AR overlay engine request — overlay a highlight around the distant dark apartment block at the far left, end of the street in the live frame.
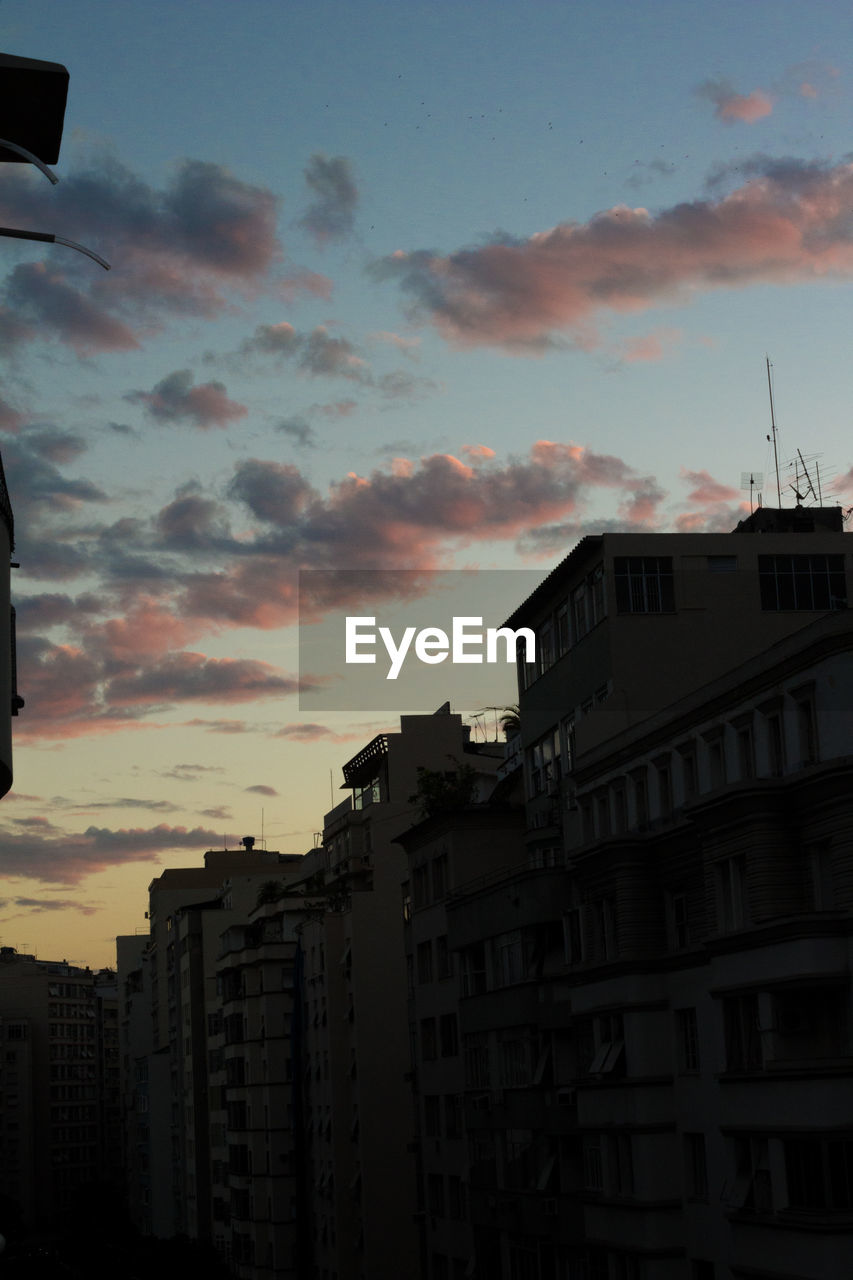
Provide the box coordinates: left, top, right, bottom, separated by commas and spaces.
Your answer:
0, 947, 117, 1229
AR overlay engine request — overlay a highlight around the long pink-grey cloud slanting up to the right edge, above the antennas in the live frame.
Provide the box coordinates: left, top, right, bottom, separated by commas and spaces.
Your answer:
374, 157, 853, 353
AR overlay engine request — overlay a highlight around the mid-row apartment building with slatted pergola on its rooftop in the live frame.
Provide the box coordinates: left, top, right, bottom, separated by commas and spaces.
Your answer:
301, 707, 500, 1280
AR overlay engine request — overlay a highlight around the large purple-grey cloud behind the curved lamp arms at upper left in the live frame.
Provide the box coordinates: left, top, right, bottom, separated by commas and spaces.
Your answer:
0, 156, 281, 356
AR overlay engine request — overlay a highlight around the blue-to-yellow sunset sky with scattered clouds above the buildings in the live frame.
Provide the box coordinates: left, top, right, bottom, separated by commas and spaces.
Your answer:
0, 0, 853, 966
